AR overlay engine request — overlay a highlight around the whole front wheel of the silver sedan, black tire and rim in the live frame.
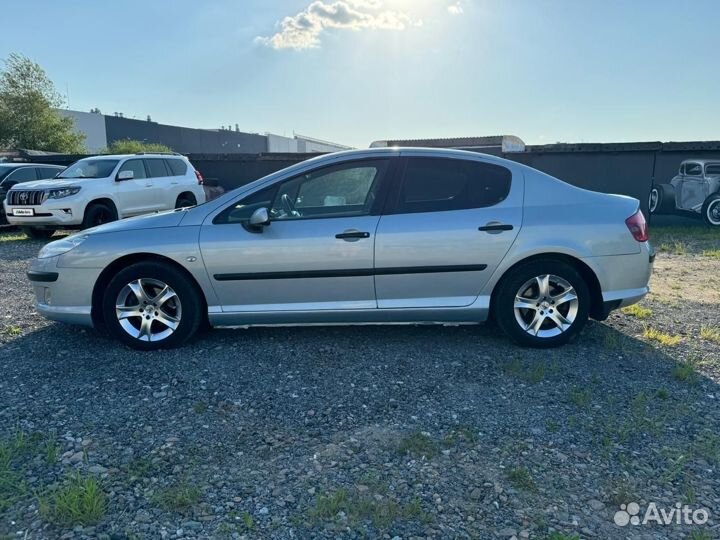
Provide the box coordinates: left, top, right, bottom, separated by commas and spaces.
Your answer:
102, 262, 204, 351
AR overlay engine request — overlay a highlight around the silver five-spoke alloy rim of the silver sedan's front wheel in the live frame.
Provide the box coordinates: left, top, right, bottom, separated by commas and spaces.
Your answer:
115, 278, 182, 342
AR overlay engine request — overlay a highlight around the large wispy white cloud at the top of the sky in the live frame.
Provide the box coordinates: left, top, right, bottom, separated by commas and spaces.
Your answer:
255, 0, 422, 49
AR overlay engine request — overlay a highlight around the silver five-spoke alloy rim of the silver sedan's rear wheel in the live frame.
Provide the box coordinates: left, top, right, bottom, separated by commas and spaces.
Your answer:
514, 274, 580, 338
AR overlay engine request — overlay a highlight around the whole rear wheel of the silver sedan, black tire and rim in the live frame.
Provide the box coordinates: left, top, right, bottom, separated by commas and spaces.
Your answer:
492, 259, 590, 348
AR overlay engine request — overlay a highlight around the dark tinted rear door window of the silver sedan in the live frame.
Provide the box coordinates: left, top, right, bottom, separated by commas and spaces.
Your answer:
396, 158, 512, 214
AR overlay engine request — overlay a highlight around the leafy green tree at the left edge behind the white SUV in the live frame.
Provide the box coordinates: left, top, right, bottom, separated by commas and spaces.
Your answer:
0, 53, 85, 154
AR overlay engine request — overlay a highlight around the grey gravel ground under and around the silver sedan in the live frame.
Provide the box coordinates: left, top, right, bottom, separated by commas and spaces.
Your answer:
0, 233, 720, 540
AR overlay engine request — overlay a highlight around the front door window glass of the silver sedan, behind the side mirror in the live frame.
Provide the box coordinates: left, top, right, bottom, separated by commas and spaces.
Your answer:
215, 160, 388, 223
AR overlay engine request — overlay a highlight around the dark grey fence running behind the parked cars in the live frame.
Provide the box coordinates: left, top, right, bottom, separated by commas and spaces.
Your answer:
23, 141, 720, 224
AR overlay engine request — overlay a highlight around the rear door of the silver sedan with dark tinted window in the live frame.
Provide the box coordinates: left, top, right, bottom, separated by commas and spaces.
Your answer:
375, 153, 524, 308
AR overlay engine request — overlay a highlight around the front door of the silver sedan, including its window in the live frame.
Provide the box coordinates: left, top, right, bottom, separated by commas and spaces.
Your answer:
200, 159, 390, 312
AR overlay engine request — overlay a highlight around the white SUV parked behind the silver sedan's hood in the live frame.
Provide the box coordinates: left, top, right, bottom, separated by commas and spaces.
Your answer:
5, 154, 205, 238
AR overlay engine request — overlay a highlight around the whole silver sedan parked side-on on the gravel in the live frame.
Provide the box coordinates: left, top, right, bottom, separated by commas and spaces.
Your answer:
28, 148, 653, 350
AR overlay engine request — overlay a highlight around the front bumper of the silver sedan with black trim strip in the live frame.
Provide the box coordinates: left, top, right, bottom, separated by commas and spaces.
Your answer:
27, 255, 101, 326
